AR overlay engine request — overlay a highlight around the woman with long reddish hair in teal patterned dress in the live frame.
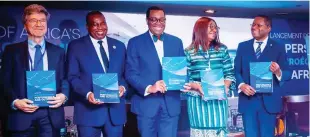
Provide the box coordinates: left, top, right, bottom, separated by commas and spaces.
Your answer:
184, 17, 235, 137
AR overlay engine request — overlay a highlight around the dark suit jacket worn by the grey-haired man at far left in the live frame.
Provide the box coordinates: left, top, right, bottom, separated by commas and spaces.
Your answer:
1, 41, 68, 131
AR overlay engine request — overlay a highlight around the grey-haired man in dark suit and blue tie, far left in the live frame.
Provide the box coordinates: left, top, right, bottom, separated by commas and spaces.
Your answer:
1, 4, 68, 137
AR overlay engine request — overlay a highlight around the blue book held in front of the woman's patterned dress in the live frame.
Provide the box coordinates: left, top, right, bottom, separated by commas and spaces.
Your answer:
200, 69, 227, 100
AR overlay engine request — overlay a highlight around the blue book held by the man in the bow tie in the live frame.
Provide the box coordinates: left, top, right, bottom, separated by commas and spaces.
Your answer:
162, 57, 188, 90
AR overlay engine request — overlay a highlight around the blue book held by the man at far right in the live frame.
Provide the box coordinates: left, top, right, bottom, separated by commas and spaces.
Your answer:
250, 62, 273, 93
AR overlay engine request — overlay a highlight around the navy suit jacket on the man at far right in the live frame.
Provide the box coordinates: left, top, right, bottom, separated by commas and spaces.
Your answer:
235, 38, 290, 113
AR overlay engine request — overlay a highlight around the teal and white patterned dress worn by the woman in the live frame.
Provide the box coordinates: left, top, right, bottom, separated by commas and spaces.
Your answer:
185, 45, 235, 137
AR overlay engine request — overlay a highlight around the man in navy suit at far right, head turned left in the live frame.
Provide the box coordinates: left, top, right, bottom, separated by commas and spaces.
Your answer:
235, 15, 290, 137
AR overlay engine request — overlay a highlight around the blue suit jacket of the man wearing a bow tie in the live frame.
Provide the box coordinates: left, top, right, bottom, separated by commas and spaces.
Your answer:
126, 31, 185, 117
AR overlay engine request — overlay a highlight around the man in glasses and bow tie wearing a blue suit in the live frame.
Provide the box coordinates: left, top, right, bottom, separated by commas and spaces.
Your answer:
126, 7, 184, 137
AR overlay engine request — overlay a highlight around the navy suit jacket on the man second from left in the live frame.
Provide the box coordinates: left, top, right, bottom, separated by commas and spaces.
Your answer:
67, 35, 128, 126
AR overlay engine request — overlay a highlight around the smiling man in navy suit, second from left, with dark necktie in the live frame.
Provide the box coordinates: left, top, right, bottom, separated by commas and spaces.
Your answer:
67, 11, 127, 137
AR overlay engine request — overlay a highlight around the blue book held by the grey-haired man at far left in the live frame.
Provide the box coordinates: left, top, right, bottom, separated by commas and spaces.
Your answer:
26, 71, 56, 107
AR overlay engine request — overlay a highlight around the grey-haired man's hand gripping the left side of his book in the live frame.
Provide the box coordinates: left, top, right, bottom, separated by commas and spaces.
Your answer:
14, 99, 39, 113
